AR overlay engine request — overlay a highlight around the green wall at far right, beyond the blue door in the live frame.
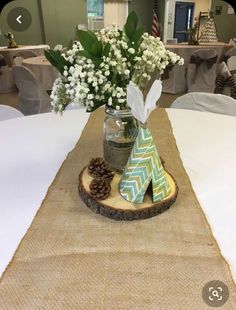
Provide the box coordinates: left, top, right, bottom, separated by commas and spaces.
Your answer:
211, 0, 236, 43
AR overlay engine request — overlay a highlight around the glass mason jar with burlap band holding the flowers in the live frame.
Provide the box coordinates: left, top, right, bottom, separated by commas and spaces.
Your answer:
103, 107, 138, 171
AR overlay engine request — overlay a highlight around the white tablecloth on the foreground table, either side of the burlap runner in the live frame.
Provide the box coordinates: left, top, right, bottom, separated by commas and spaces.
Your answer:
0, 109, 236, 280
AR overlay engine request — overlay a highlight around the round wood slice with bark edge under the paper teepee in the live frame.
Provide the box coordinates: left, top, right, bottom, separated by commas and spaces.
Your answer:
78, 167, 178, 221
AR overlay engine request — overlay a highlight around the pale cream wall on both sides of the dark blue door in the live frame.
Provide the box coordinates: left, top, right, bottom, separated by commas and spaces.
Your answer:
165, 0, 211, 39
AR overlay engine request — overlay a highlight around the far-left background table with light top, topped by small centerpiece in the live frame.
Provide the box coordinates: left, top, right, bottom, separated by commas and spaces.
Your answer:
0, 44, 49, 67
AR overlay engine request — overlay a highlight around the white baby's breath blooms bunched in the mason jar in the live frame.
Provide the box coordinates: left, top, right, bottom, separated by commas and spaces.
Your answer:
51, 26, 183, 112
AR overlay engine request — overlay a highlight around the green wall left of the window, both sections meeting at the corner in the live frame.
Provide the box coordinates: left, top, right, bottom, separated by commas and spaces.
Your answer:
0, 0, 87, 48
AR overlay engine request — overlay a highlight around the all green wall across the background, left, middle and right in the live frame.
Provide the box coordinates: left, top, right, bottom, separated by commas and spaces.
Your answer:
4, 0, 233, 47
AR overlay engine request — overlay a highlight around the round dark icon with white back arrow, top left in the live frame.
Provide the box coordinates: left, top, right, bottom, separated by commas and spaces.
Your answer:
7, 7, 32, 32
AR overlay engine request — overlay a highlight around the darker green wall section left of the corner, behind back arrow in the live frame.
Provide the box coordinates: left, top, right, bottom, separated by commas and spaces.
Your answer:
0, 0, 43, 46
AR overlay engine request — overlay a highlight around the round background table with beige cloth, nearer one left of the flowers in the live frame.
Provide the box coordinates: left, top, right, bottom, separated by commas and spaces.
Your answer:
22, 56, 58, 91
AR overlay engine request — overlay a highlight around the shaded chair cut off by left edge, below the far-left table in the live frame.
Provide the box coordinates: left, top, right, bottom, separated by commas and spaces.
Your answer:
0, 55, 15, 93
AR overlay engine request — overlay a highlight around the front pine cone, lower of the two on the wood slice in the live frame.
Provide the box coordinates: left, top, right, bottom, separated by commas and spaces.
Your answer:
89, 178, 111, 200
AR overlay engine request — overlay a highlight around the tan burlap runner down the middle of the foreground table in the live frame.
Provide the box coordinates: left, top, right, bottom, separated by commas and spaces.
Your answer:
0, 109, 236, 310
